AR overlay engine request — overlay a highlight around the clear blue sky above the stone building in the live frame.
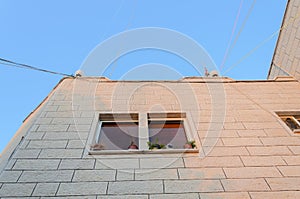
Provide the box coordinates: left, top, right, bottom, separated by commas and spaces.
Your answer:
0, 0, 286, 151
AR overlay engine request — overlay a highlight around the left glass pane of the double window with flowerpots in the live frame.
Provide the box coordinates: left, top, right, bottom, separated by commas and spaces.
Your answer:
99, 122, 139, 150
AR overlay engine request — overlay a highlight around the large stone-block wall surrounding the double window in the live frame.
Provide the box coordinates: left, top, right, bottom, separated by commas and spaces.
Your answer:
0, 78, 300, 199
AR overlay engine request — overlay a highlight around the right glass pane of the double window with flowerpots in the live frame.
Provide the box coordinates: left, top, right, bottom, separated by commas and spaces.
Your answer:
149, 121, 187, 149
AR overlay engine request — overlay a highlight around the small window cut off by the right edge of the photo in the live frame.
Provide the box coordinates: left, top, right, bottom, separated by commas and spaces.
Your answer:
277, 112, 300, 133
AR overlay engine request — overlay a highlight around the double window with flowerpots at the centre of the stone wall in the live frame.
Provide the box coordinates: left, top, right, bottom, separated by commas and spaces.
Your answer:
90, 113, 198, 153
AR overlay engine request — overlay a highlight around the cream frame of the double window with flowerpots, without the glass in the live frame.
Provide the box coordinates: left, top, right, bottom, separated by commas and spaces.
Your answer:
88, 112, 200, 155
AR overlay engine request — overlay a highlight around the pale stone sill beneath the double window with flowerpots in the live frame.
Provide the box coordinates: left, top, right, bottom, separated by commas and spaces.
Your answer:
89, 149, 199, 155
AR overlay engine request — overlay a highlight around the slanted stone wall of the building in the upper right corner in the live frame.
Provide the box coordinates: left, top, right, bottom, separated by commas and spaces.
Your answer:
268, 0, 300, 80
